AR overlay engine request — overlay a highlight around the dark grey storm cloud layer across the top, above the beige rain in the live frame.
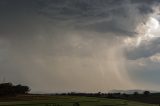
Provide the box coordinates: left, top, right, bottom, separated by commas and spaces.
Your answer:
0, 0, 156, 38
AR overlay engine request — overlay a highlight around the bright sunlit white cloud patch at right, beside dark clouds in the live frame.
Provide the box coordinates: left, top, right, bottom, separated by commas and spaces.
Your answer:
124, 17, 160, 47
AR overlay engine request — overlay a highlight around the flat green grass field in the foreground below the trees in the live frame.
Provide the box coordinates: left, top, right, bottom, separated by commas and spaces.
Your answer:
0, 96, 158, 106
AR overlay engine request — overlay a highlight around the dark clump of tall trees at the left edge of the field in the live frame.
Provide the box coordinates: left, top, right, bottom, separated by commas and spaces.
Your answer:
0, 83, 30, 96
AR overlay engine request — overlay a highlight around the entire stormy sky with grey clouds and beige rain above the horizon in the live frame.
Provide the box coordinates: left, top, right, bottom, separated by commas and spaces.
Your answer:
0, 0, 160, 93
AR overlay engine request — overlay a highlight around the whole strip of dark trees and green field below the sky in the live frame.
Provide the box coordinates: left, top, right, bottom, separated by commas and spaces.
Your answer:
0, 83, 160, 106
